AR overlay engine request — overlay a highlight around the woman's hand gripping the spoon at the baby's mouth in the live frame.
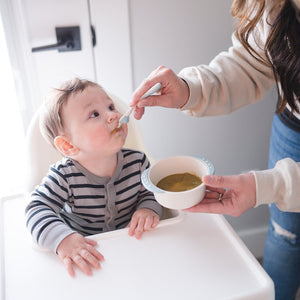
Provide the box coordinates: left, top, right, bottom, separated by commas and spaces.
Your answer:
130, 66, 190, 120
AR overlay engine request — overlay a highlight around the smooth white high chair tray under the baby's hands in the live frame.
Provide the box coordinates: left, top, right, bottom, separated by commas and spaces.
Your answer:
1, 199, 274, 300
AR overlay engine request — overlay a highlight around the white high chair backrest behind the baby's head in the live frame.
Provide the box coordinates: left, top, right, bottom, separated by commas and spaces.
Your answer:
26, 92, 152, 192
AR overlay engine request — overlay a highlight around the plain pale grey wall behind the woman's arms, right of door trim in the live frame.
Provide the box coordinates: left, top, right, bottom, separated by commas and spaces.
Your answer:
129, 0, 276, 256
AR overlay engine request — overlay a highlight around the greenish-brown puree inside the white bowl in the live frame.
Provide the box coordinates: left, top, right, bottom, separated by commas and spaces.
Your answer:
157, 173, 202, 192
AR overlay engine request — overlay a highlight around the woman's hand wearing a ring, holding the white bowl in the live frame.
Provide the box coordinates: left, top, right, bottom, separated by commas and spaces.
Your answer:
185, 173, 256, 217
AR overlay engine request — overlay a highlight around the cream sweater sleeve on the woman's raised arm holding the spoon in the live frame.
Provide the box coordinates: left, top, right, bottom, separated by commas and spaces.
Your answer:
179, 10, 275, 117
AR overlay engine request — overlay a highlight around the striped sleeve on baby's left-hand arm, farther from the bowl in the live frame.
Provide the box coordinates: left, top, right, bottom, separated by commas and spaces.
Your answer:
25, 166, 74, 253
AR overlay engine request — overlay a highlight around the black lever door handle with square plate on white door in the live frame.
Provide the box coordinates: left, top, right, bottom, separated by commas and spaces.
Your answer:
31, 26, 81, 52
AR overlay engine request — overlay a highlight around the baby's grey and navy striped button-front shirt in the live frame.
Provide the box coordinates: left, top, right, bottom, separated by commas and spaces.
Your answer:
26, 149, 162, 252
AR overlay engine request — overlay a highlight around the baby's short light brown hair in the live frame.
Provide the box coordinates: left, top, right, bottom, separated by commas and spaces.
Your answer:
39, 78, 100, 148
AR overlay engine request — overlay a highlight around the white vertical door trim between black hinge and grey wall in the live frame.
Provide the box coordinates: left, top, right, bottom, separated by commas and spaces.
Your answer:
89, 0, 132, 100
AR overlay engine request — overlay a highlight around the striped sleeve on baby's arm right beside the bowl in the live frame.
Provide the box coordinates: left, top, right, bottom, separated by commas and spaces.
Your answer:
136, 154, 163, 219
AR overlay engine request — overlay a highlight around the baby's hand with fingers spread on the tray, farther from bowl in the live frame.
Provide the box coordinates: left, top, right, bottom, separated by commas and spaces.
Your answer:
57, 233, 104, 277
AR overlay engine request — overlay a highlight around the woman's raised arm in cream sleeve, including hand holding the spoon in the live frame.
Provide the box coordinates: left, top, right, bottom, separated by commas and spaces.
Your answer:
131, 9, 275, 119
